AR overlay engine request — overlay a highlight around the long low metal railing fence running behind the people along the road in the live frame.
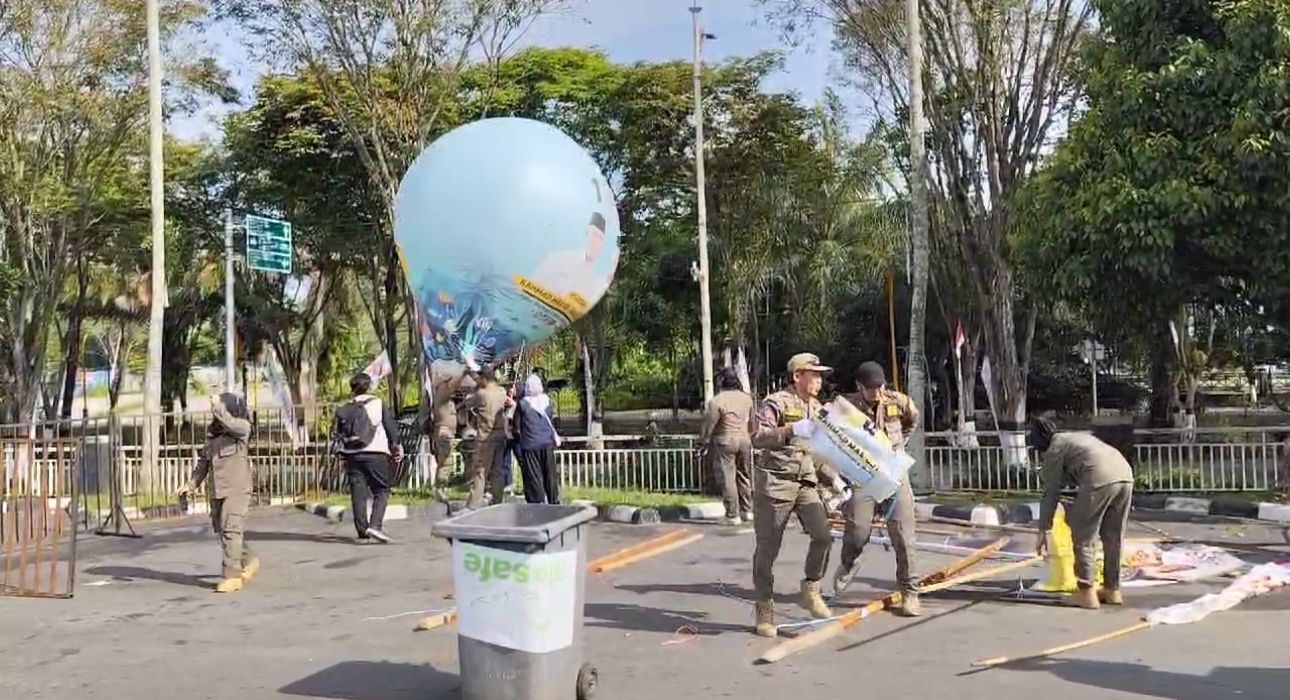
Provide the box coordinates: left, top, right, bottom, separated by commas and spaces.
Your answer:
0, 409, 1290, 513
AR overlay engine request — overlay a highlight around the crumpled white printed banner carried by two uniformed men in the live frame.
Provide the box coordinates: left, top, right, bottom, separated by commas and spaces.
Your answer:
808, 397, 913, 501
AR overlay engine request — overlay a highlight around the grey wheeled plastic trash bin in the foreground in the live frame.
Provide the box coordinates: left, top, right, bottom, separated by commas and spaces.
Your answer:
432, 503, 597, 700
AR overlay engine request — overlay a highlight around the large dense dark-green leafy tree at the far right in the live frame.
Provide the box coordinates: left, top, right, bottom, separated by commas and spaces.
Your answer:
1022, 0, 1290, 422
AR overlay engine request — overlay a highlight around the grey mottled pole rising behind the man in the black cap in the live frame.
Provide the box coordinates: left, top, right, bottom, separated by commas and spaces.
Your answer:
904, 0, 933, 490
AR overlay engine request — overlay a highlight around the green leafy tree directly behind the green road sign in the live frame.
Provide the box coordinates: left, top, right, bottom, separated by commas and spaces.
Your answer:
224, 76, 381, 403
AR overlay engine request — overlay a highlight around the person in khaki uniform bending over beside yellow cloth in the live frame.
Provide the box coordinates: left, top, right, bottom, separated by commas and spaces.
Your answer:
1029, 418, 1133, 610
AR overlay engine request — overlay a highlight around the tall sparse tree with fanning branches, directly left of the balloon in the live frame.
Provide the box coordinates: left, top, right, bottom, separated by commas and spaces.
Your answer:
219, 0, 562, 406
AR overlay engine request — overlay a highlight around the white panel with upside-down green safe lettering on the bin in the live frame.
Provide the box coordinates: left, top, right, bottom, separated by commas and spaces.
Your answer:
453, 540, 578, 654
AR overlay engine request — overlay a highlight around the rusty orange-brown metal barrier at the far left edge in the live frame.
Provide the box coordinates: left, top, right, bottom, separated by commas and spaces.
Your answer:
0, 440, 80, 598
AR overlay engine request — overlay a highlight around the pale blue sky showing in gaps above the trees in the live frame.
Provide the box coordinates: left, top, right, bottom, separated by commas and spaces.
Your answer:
170, 0, 832, 139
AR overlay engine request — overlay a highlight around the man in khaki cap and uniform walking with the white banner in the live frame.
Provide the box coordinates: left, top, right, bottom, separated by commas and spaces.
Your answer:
752, 353, 836, 637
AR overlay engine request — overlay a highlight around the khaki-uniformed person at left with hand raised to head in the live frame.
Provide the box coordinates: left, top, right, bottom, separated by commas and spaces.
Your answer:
179, 393, 259, 593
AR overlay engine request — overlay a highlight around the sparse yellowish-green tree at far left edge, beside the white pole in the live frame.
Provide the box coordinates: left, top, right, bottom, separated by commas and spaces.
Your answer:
0, 0, 230, 423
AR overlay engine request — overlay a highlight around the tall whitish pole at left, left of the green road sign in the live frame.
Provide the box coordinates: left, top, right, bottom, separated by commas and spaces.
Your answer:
141, 0, 168, 489
